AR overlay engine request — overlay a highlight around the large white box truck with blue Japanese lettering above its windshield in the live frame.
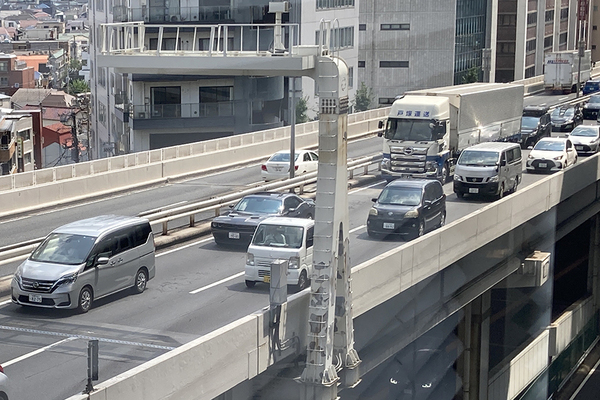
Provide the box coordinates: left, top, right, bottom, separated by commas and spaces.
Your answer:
379, 83, 524, 183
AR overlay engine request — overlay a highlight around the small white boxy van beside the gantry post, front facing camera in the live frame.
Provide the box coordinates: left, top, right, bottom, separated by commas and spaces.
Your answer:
245, 217, 315, 290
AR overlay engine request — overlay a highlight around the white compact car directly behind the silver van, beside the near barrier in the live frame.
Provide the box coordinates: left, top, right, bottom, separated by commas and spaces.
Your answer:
527, 138, 577, 172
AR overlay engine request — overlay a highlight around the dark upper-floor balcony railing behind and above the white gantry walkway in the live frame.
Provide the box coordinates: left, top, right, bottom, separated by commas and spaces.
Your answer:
113, 6, 232, 23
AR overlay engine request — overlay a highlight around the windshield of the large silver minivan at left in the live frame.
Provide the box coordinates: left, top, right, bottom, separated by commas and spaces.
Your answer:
29, 233, 96, 265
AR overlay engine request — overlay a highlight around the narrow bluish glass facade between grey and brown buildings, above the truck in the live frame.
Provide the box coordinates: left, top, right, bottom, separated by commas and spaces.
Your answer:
454, 0, 487, 85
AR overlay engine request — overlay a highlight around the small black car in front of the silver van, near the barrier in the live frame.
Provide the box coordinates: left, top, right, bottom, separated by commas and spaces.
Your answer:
367, 179, 446, 239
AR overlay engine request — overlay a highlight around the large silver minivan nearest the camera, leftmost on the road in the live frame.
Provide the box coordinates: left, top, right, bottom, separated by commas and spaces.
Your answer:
11, 215, 155, 312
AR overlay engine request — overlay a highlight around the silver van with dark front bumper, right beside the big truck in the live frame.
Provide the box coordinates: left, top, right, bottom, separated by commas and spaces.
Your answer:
454, 142, 523, 198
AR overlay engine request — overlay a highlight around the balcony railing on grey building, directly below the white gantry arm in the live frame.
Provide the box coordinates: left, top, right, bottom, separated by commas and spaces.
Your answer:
132, 101, 235, 119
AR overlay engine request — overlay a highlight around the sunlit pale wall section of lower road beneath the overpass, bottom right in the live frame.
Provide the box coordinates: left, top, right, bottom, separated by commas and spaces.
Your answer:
488, 330, 550, 400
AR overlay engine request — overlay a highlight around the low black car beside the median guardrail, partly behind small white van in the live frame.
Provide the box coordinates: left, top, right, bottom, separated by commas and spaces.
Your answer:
211, 192, 315, 246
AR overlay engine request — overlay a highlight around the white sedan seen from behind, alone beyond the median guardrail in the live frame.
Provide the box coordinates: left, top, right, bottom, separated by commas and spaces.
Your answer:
260, 150, 319, 181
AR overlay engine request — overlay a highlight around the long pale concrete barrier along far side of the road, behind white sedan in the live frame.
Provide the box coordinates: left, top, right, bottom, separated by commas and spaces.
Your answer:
0, 107, 389, 216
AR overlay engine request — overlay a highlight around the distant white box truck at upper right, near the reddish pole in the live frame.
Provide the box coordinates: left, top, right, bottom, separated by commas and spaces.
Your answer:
544, 50, 592, 93
